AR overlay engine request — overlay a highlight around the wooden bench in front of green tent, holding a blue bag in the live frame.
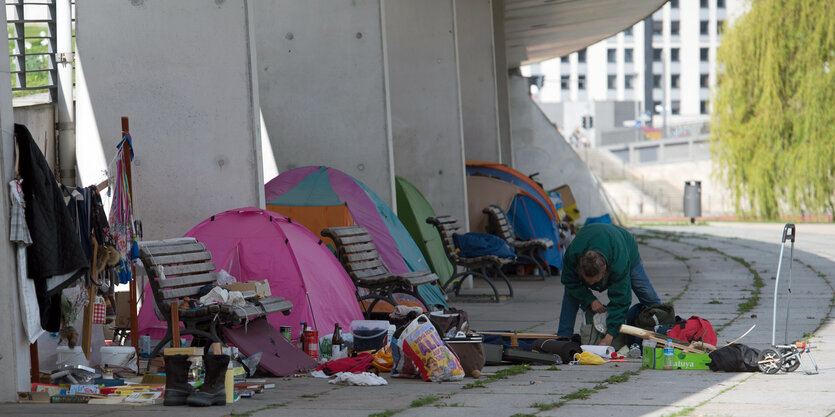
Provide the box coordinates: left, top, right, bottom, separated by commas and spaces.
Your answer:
426, 216, 514, 302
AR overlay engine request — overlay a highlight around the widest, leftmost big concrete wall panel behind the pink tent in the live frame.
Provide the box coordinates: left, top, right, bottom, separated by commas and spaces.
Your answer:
76, 0, 264, 239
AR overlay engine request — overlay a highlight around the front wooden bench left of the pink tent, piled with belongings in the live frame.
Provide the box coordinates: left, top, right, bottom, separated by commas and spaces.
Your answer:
139, 238, 293, 358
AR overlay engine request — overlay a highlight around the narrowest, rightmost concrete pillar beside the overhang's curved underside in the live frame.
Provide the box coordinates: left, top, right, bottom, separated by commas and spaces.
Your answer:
492, 0, 514, 166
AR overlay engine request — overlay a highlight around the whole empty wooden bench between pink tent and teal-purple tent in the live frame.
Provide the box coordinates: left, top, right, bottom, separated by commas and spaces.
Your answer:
322, 225, 438, 317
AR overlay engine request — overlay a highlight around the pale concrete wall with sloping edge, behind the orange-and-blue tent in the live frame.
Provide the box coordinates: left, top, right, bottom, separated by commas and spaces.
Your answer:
510, 77, 617, 223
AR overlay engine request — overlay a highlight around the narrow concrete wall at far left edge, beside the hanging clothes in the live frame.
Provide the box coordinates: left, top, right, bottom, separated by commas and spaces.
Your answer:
0, 1, 29, 396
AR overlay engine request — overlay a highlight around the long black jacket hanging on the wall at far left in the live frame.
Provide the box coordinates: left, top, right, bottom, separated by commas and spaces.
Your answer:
15, 124, 88, 332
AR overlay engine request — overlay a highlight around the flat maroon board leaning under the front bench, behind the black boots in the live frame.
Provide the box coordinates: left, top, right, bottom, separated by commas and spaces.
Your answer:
223, 318, 318, 376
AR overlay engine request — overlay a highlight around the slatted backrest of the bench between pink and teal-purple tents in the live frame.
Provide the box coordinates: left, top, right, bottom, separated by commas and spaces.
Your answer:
322, 225, 391, 284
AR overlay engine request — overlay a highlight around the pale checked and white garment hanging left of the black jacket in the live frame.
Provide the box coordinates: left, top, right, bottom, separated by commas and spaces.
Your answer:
9, 180, 44, 343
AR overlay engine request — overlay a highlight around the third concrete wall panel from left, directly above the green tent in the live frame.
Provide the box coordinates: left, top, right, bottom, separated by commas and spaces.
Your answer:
383, 0, 468, 225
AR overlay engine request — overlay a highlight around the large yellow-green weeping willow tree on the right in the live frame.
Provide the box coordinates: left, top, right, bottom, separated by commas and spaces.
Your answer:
711, 0, 835, 218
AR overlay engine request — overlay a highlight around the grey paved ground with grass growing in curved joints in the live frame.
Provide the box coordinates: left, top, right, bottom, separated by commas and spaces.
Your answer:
0, 222, 835, 417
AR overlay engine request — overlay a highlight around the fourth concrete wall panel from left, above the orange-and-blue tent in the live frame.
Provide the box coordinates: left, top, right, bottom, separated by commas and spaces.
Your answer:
455, 0, 506, 162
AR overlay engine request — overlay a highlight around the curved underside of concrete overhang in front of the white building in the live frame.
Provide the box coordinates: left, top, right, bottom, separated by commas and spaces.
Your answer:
504, 0, 667, 68
